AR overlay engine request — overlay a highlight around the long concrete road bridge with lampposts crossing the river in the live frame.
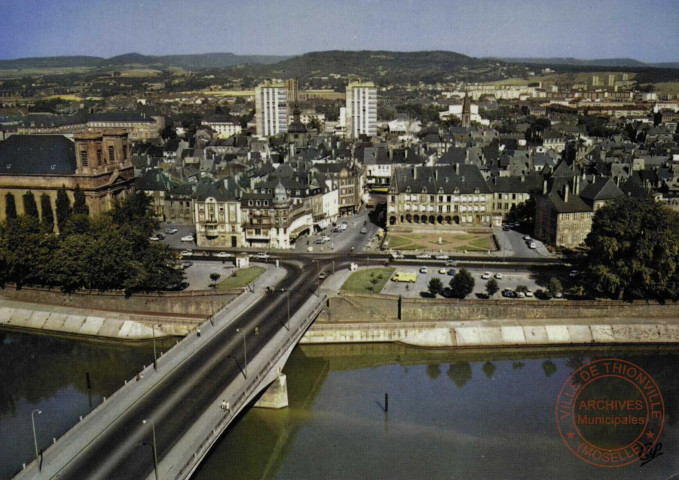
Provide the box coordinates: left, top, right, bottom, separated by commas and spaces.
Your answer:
15, 258, 336, 480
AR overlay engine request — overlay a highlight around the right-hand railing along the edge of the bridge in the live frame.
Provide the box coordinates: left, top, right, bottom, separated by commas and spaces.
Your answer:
175, 295, 328, 480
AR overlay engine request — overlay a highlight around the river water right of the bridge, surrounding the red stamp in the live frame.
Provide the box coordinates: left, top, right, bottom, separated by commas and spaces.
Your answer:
195, 344, 679, 480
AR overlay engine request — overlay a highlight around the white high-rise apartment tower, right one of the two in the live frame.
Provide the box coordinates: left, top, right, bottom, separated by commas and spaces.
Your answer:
346, 82, 377, 138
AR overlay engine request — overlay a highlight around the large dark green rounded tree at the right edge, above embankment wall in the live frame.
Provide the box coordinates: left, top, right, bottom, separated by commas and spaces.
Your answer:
584, 197, 679, 301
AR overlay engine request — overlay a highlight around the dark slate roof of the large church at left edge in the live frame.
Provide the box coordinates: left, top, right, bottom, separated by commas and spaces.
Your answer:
0, 135, 77, 175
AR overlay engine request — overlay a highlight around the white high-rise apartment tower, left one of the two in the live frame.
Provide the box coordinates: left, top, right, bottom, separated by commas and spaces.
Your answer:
255, 82, 288, 137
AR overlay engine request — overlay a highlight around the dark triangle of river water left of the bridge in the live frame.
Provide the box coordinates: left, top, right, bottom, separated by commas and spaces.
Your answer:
0, 330, 175, 479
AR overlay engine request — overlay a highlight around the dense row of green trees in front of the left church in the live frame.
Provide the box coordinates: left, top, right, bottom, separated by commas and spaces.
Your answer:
0, 192, 183, 293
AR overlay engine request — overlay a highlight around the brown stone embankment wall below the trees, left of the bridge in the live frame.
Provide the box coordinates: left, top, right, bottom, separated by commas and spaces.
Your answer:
0, 286, 242, 318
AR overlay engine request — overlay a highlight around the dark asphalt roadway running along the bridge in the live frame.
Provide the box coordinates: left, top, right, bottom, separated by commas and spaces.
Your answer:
51, 261, 327, 480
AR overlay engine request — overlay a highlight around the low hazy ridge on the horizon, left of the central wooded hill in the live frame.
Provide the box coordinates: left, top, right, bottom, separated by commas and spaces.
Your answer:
0, 53, 290, 70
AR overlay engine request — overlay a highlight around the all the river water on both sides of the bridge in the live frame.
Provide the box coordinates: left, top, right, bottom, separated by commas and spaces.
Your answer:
0, 332, 679, 480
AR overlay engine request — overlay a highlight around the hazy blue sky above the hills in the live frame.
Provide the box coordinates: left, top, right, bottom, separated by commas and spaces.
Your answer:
0, 0, 679, 62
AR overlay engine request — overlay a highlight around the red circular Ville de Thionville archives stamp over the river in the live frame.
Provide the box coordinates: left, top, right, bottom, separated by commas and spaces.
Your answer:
556, 358, 665, 467
